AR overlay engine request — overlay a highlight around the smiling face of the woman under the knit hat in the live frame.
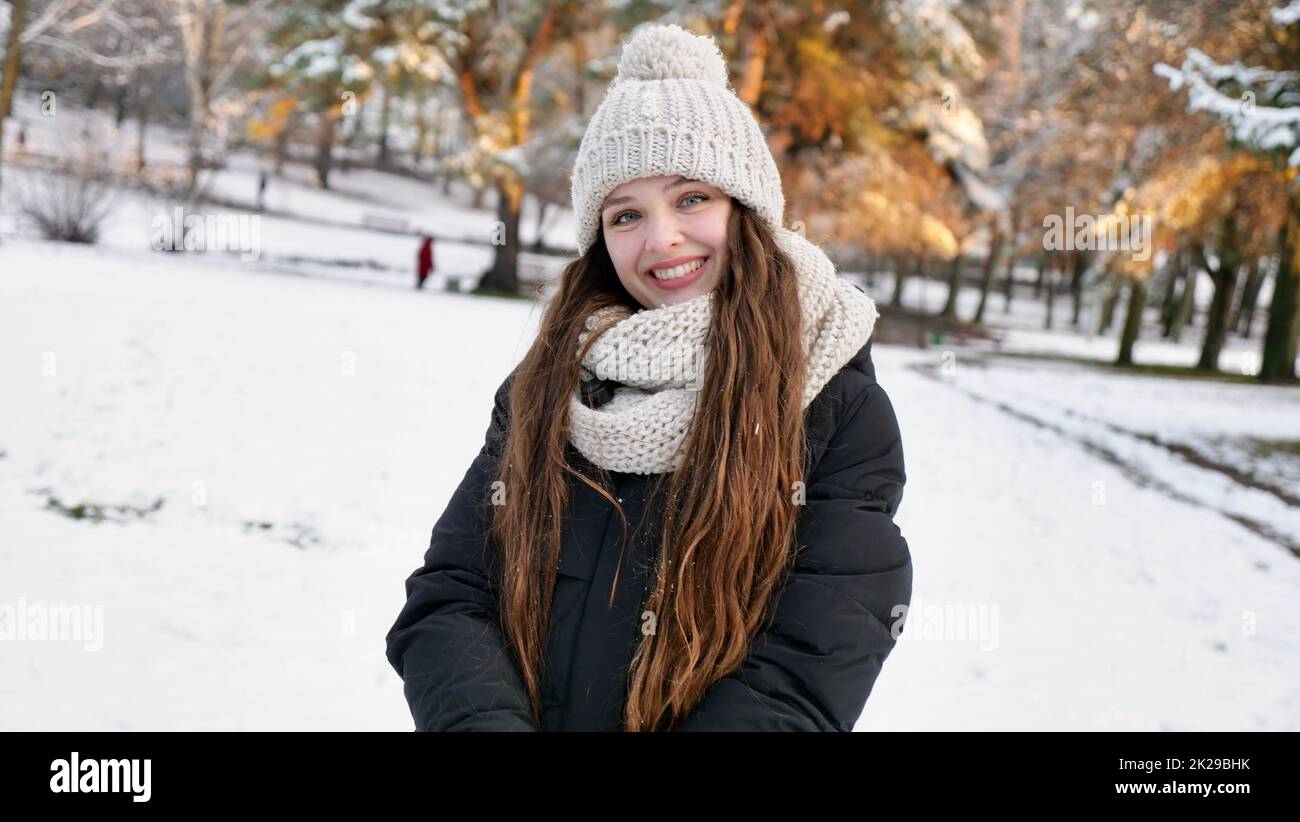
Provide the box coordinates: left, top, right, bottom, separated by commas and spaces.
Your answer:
601, 176, 733, 308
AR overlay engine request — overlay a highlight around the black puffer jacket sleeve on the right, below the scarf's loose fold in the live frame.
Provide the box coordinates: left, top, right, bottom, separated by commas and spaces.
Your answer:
677, 380, 911, 731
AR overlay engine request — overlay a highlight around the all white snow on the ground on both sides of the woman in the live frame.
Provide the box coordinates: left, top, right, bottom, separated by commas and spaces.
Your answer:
0, 237, 1300, 730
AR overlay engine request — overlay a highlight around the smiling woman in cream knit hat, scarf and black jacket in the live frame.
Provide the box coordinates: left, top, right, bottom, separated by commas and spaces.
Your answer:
387, 26, 911, 731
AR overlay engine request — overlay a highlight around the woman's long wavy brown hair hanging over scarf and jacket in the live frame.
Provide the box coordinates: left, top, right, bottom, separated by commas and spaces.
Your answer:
491, 200, 807, 731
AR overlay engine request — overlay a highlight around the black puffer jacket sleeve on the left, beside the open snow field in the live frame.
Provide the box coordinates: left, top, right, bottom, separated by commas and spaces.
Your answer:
386, 375, 537, 731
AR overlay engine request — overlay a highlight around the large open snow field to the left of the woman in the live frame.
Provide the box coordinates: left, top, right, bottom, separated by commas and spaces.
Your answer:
0, 242, 536, 730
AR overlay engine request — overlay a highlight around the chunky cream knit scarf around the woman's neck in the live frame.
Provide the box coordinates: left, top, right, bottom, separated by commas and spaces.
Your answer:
569, 228, 879, 473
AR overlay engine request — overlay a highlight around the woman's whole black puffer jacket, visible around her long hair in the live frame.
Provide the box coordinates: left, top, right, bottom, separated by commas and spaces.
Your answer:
387, 342, 911, 731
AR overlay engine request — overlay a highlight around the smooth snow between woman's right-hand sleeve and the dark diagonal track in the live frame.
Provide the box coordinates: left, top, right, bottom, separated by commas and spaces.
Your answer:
859, 346, 1300, 730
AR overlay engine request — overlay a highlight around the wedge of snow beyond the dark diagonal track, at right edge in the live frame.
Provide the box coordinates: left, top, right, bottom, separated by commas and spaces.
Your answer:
915, 351, 1300, 558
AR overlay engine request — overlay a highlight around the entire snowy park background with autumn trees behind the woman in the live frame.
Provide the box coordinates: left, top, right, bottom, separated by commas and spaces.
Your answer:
0, 0, 1300, 730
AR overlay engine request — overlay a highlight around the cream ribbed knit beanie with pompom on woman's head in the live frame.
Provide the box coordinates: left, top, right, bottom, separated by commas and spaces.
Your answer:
569, 23, 785, 255
